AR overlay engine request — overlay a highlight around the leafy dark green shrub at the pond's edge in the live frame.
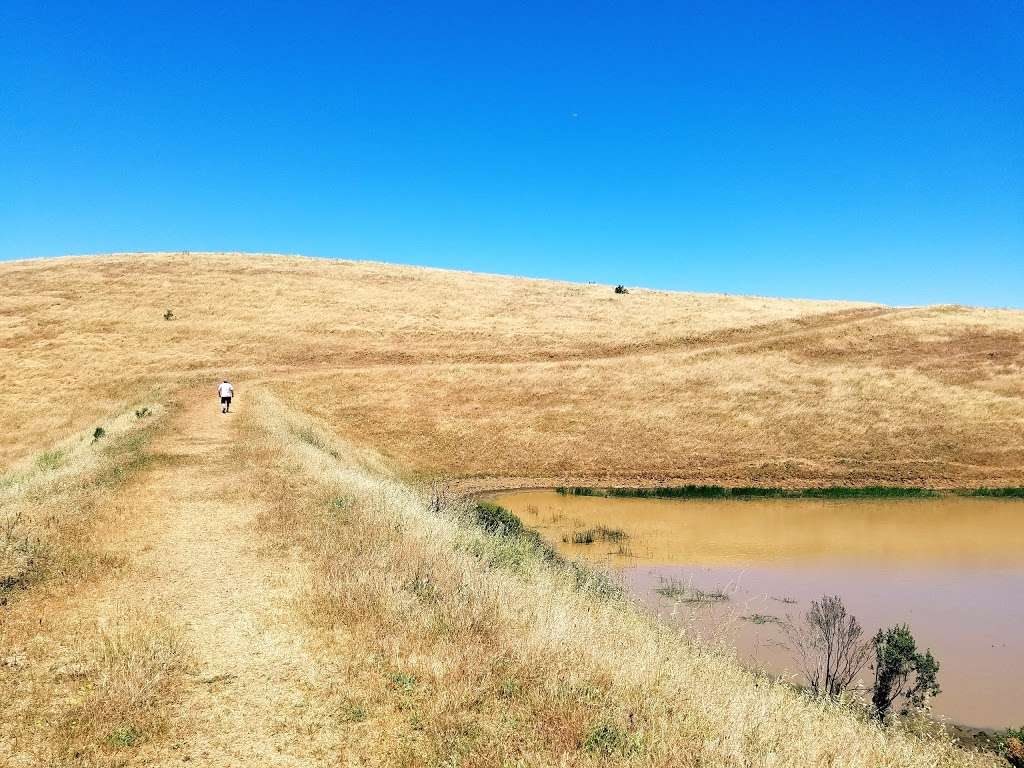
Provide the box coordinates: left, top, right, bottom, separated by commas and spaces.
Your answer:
871, 624, 941, 720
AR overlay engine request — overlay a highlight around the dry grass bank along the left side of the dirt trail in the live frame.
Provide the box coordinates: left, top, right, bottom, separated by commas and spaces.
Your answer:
0, 401, 187, 767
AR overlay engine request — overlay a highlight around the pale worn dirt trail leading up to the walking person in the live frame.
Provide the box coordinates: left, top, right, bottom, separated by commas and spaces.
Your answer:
112, 393, 338, 766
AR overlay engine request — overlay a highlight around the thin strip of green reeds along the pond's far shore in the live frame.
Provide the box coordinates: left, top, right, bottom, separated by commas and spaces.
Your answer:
555, 485, 1024, 499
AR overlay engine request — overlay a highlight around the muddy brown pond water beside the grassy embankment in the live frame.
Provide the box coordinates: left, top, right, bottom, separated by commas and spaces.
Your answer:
495, 490, 1024, 727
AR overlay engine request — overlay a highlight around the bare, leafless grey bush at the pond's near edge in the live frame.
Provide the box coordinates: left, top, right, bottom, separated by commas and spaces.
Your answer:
783, 595, 871, 696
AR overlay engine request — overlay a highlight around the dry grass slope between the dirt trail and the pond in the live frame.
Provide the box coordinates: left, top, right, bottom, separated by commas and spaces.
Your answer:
241, 393, 989, 768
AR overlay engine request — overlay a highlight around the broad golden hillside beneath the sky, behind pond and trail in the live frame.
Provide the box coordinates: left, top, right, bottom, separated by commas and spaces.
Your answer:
0, 254, 1024, 486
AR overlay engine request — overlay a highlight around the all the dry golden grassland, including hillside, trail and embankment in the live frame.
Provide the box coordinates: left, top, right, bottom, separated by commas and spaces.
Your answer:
0, 254, 1024, 768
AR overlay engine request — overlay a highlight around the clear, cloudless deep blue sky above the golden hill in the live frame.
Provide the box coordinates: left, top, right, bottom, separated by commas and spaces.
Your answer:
0, 0, 1024, 306
